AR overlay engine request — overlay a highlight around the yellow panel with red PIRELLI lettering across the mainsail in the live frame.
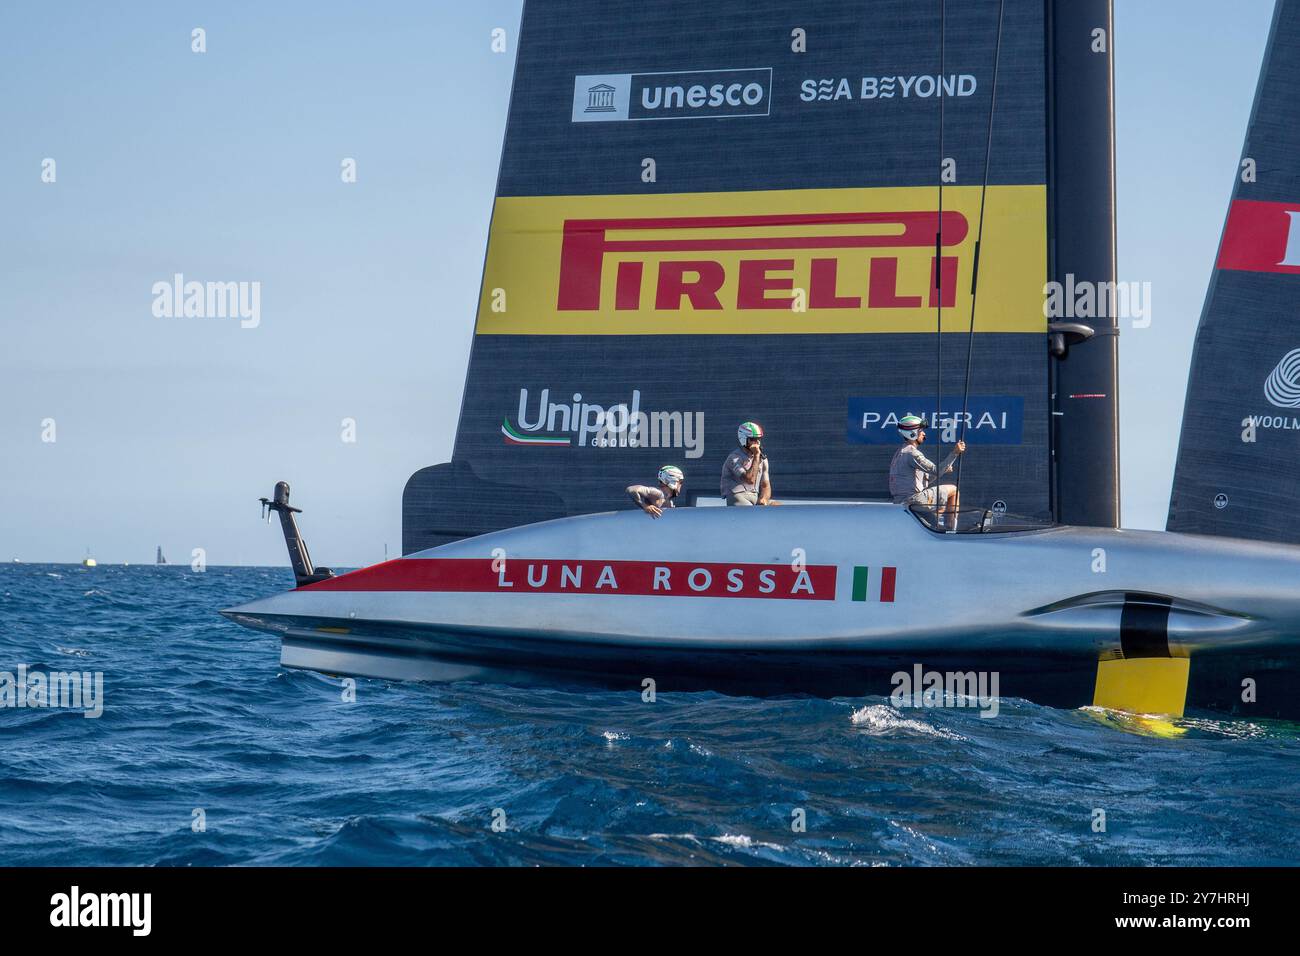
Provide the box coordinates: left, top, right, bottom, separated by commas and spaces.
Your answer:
476, 186, 1047, 336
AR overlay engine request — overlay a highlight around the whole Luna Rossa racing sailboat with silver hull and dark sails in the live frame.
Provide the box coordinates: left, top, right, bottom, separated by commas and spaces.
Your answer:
222, 0, 1300, 717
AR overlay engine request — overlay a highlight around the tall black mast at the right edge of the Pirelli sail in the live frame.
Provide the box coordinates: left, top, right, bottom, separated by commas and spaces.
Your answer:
1047, 0, 1119, 528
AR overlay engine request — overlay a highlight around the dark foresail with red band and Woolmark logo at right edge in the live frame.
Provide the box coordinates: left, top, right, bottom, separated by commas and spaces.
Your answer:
1167, 0, 1300, 544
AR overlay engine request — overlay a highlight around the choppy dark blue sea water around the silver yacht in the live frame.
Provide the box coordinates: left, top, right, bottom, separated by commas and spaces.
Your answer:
0, 564, 1300, 866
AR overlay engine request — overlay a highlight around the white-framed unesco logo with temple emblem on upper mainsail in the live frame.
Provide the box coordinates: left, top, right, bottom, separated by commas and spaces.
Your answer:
572, 66, 772, 122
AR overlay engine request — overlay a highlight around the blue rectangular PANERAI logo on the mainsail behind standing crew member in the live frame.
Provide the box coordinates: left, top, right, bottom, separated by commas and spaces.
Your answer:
846, 395, 1024, 445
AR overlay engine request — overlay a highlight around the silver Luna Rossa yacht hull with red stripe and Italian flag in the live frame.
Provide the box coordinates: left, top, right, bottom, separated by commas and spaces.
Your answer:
222, 503, 1300, 717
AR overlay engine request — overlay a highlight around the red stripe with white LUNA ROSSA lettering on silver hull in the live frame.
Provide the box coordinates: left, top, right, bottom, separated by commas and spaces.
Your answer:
304, 557, 837, 601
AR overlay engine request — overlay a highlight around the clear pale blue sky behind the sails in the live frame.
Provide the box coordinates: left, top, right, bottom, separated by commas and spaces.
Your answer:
0, 0, 1273, 566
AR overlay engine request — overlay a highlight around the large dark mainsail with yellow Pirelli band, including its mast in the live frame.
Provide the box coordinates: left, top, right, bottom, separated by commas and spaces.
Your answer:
403, 0, 1118, 553
